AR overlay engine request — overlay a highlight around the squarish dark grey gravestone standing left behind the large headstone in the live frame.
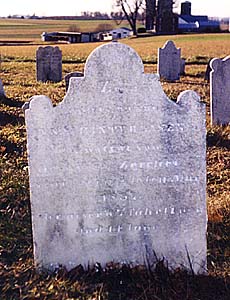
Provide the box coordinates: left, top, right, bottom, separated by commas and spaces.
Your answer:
36, 46, 62, 82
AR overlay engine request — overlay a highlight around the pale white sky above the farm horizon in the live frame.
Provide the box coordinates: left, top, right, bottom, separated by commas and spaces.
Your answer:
0, 0, 230, 17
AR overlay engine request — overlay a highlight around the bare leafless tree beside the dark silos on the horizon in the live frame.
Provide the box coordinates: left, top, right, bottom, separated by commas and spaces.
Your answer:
115, 0, 145, 35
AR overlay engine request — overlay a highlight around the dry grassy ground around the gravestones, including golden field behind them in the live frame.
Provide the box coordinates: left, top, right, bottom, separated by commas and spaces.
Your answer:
0, 34, 230, 300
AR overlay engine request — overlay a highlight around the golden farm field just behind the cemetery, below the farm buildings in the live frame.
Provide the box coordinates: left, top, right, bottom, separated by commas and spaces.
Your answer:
0, 34, 230, 64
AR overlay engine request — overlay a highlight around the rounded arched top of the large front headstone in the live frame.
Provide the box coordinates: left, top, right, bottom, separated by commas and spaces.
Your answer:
84, 42, 144, 82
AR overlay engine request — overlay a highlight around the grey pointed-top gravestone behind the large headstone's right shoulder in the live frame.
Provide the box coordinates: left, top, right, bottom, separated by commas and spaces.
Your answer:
157, 41, 182, 81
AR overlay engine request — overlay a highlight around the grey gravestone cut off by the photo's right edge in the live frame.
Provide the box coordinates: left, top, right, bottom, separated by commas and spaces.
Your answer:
210, 56, 230, 125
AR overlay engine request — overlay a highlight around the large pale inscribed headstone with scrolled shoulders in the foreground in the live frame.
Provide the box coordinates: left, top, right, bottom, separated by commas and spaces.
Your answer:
25, 43, 207, 272
